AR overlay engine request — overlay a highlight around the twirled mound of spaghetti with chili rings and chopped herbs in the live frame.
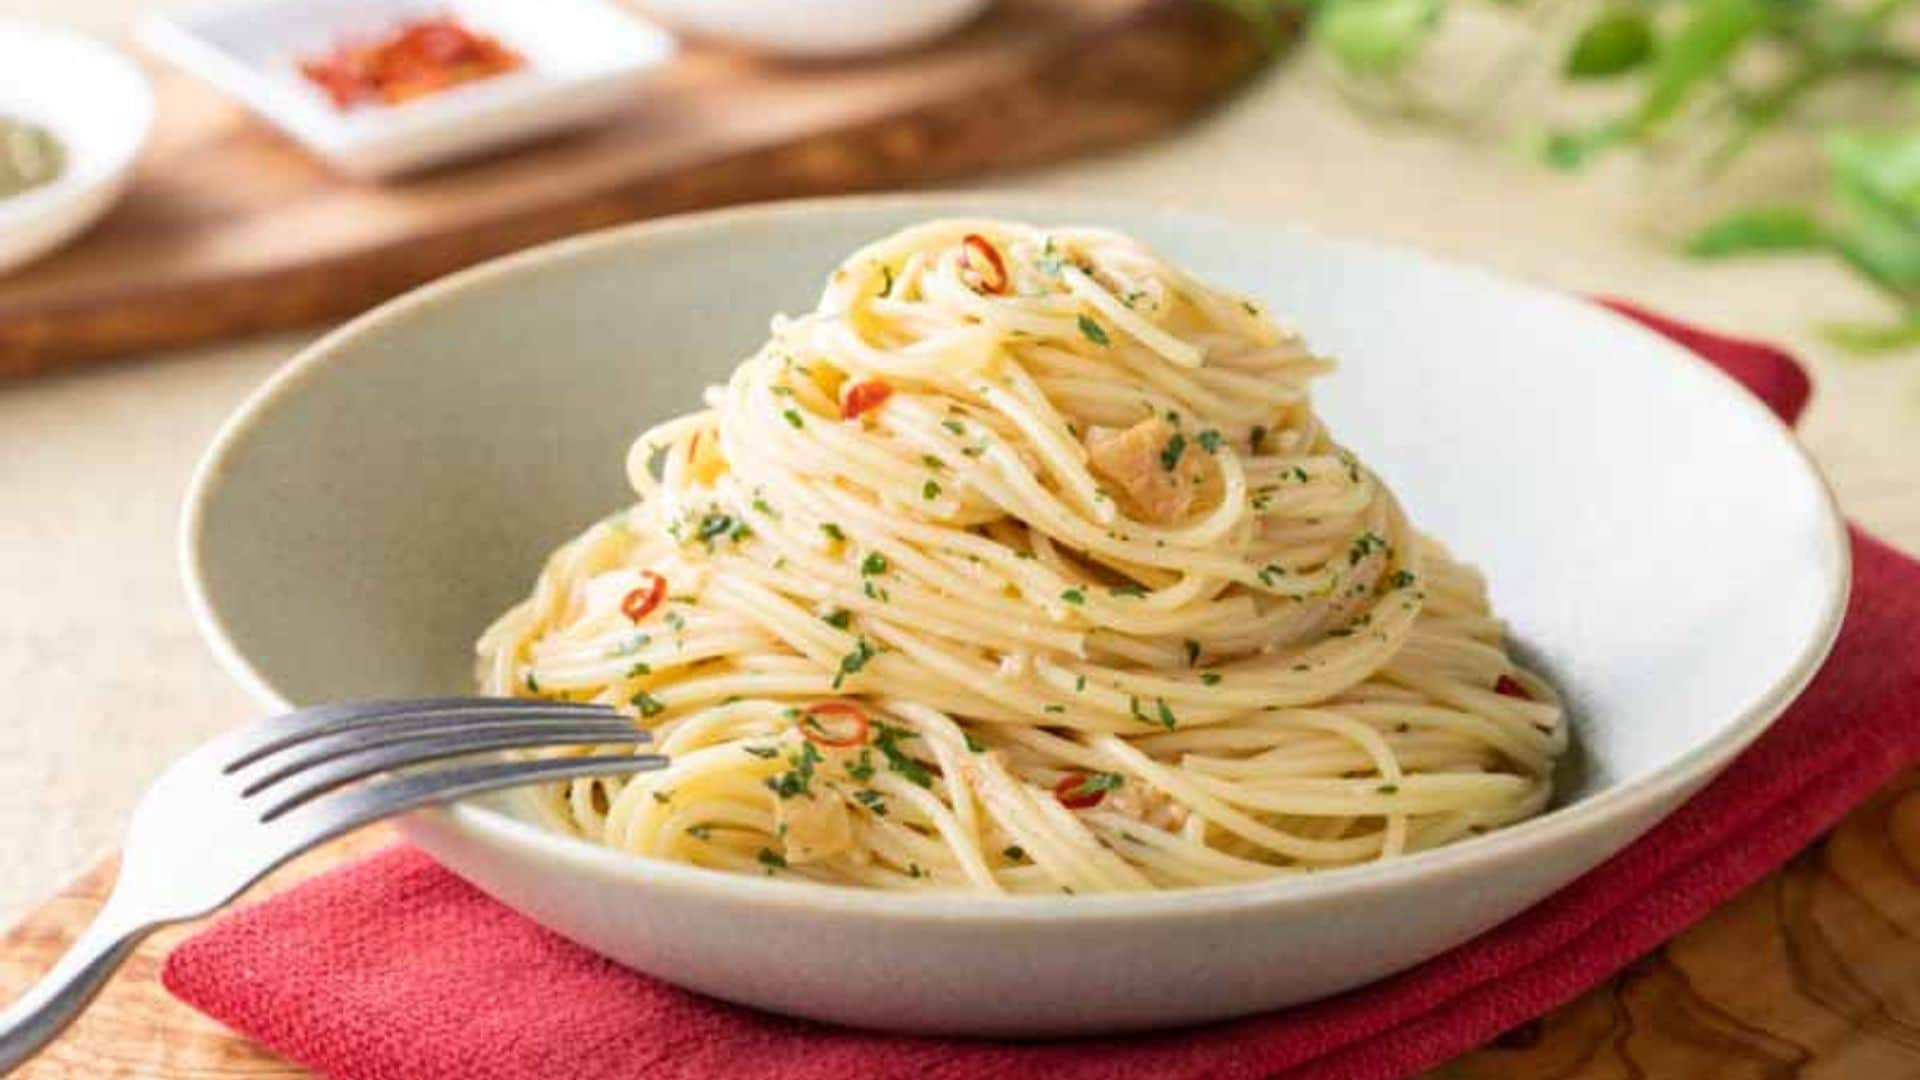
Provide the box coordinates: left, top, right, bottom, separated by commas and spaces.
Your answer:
478, 221, 1567, 894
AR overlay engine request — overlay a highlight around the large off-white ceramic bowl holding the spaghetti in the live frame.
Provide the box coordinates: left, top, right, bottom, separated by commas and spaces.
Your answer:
184, 196, 1849, 1036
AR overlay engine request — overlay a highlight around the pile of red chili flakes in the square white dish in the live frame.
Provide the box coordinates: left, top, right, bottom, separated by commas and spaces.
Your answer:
300, 15, 526, 110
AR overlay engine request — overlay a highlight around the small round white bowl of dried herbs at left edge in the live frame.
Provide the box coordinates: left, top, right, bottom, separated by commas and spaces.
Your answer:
0, 17, 154, 273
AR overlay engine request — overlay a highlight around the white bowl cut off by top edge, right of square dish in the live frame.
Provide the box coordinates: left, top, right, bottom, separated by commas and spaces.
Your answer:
632, 0, 993, 60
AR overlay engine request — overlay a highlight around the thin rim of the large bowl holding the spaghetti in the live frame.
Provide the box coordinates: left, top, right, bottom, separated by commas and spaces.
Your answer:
179, 190, 1853, 922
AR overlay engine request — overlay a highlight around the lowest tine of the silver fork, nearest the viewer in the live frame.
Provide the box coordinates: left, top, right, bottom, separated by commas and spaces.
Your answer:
266, 753, 668, 847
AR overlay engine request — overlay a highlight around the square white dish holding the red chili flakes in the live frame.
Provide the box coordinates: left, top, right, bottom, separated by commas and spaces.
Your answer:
138, 0, 674, 177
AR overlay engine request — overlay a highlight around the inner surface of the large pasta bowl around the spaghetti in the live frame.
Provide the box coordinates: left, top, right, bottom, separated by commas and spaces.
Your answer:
184, 196, 1845, 822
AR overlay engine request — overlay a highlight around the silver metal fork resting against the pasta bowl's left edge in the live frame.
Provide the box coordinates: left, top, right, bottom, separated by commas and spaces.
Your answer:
0, 698, 666, 1074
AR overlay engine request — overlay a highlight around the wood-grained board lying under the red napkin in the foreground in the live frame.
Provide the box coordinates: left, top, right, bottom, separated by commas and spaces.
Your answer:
0, 769, 1920, 1080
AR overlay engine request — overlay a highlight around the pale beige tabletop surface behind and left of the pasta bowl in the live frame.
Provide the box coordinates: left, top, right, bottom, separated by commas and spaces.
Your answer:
0, 0, 1920, 919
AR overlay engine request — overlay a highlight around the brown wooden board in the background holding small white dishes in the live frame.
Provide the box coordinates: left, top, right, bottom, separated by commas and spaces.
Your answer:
0, 0, 1290, 375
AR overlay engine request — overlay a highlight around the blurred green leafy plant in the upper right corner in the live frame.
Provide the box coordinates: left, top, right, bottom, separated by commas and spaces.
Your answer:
1217, 0, 1920, 352
